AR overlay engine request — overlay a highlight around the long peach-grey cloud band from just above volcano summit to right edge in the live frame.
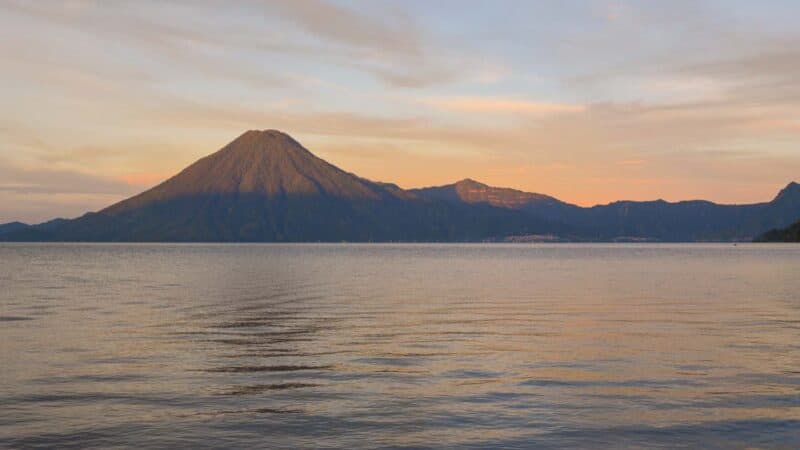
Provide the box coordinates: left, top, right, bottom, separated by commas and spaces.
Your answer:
120, 88, 800, 164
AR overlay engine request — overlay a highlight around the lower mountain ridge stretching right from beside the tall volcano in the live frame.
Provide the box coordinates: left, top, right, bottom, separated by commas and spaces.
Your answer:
412, 179, 800, 242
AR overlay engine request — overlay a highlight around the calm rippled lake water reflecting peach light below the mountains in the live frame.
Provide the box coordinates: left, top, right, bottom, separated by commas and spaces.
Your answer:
0, 244, 800, 448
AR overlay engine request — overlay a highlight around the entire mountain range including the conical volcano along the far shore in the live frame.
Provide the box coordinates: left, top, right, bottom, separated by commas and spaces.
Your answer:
0, 130, 800, 242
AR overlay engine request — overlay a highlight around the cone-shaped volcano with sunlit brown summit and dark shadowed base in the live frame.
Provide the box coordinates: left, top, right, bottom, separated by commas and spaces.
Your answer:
10, 130, 559, 242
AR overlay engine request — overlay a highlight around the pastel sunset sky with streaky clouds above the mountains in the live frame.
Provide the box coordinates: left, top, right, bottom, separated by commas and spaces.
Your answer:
0, 0, 800, 223
